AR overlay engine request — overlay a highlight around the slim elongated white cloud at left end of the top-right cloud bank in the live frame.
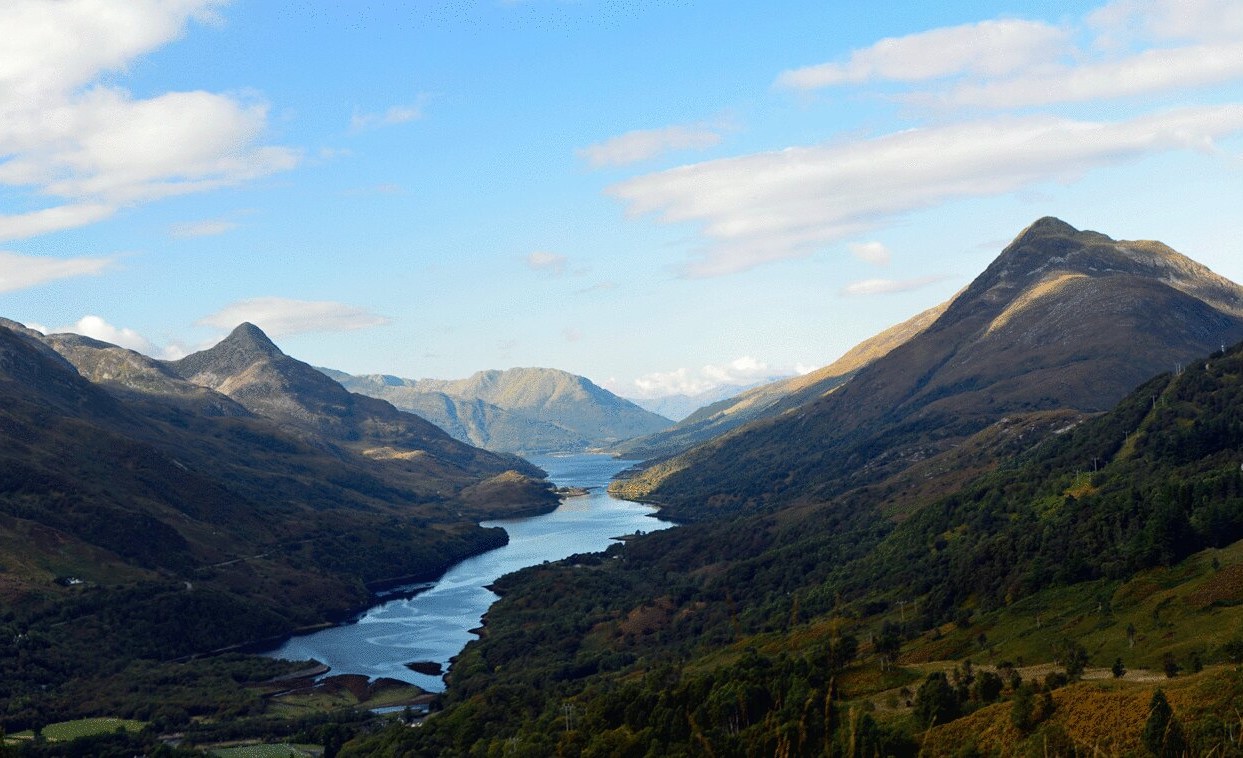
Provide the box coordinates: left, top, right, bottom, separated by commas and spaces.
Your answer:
777, 20, 1069, 89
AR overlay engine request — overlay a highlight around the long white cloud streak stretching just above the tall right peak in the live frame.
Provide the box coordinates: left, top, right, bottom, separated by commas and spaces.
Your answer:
607, 104, 1243, 277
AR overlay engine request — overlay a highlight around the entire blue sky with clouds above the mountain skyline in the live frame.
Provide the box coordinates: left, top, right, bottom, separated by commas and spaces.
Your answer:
0, 0, 1243, 398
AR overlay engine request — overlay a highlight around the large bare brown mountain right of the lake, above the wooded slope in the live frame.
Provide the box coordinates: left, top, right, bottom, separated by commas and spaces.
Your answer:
617, 217, 1243, 518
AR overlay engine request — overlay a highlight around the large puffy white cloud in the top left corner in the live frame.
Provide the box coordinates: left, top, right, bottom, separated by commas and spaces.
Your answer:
0, 0, 300, 239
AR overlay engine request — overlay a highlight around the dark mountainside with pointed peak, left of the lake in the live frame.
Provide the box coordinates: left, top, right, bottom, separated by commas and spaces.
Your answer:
0, 315, 558, 723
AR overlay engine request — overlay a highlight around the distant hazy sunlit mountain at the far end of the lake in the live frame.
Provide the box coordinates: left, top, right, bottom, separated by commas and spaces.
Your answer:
328, 368, 671, 452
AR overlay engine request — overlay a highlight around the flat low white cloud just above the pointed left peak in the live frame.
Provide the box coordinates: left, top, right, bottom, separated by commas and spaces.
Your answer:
196, 297, 388, 337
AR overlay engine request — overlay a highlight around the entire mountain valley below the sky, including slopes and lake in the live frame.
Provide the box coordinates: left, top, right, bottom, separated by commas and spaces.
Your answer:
7, 219, 1243, 756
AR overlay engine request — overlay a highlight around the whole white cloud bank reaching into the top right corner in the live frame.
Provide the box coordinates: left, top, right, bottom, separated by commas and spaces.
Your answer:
777, 0, 1243, 109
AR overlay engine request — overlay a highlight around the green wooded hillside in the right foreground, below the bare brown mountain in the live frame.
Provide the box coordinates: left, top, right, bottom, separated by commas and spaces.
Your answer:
362, 344, 1243, 756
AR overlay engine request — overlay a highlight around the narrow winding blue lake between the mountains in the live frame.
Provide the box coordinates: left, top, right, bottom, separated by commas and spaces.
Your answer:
264, 454, 674, 692
